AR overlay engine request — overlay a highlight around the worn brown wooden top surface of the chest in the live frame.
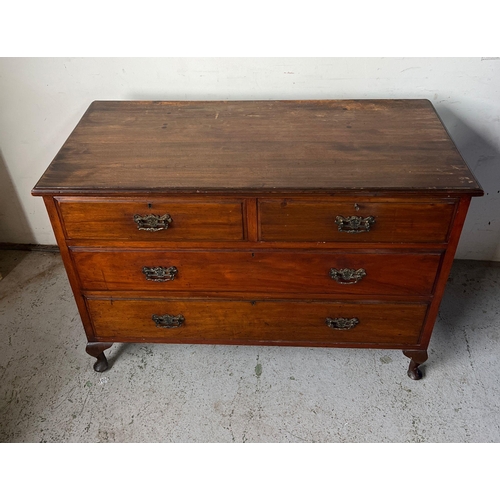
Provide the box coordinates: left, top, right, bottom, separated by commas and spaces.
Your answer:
32, 100, 482, 195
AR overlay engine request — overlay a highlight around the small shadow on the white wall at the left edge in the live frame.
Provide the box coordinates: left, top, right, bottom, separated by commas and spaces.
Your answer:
0, 150, 35, 243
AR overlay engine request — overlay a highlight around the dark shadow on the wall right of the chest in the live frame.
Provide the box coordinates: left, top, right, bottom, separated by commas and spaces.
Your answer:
437, 107, 500, 261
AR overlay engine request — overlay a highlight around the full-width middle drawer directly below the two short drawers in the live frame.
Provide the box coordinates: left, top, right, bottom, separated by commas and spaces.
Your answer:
72, 248, 441, 295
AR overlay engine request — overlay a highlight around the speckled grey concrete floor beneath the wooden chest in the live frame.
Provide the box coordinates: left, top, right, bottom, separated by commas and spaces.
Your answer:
0, 250, 500, 443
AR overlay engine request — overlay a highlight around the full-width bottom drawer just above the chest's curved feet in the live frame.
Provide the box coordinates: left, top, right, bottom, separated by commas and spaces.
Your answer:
87, 297, 427, 345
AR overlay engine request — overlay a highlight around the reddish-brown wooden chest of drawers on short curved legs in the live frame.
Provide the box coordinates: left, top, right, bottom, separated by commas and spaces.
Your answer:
33, 100, 482, 379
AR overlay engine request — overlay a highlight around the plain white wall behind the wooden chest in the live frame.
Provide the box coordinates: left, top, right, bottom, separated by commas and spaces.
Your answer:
0, 57, 500, 261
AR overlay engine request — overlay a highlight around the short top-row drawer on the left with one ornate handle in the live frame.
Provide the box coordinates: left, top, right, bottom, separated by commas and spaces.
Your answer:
59, 199, 244, 241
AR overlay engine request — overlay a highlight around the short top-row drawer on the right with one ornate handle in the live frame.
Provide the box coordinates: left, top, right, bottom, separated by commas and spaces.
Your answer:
259, 200, 455, 243
